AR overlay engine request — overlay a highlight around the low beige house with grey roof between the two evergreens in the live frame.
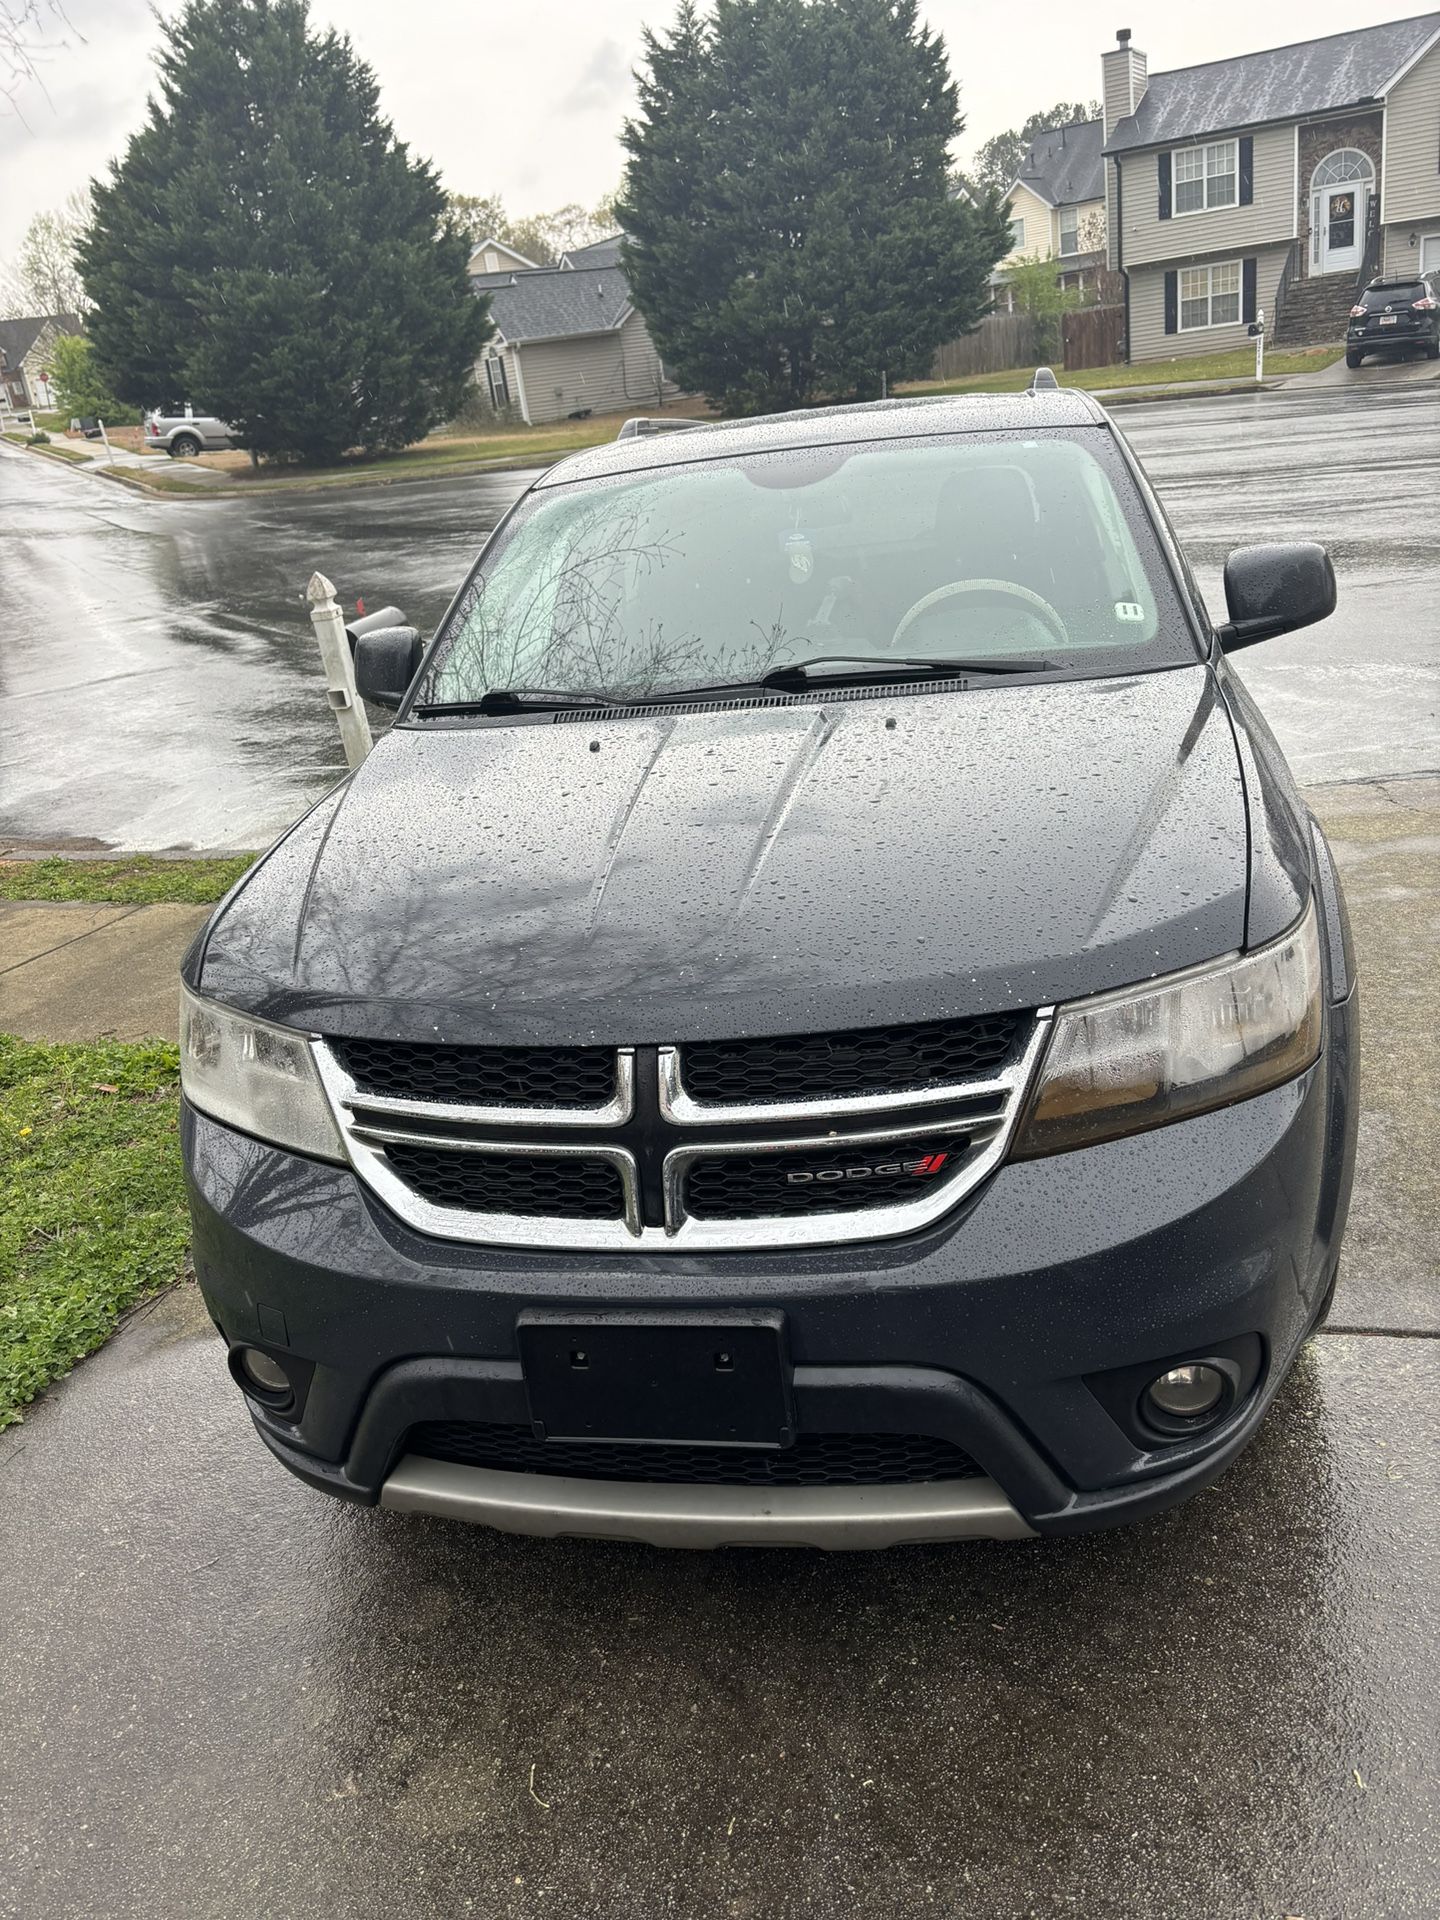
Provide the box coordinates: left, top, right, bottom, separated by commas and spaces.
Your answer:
470, 234, 680, 426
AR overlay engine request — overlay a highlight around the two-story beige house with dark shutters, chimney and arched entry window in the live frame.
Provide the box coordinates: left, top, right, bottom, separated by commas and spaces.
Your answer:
1100, 13, 1440, 361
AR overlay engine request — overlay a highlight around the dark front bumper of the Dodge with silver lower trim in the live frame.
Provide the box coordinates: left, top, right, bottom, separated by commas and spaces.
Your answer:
182, 998, 1356, 1546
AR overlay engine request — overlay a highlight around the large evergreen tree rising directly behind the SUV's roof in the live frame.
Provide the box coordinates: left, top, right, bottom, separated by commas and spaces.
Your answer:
616, 0, 1010, 413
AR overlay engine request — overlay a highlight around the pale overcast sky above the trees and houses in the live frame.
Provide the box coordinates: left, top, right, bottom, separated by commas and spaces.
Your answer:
0, 0, 1409, 261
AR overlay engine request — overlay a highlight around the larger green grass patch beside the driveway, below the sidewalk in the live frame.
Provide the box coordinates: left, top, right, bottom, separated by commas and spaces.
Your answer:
0, 1035, 190, 1427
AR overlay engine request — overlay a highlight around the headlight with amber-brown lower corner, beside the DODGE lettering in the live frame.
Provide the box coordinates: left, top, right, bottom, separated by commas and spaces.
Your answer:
1012, 900, 1321, 1158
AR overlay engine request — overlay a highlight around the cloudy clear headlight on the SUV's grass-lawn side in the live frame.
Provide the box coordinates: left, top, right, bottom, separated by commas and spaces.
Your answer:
180, 987, 346, 1160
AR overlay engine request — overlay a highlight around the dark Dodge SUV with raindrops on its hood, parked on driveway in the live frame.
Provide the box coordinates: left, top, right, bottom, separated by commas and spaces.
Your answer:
182, 392, 1356, 1546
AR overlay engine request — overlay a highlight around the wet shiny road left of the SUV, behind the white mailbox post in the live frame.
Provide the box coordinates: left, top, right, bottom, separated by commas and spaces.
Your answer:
0, 447, 526, 849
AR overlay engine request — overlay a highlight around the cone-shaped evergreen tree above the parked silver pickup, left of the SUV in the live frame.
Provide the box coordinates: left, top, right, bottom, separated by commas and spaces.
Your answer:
79, 0, 490, 461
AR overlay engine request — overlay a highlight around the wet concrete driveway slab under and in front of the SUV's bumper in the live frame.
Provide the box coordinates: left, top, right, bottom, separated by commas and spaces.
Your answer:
0, 1292, 1440, 1920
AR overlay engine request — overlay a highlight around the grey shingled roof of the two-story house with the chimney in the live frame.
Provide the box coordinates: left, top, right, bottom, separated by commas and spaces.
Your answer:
1106, 13, 1440, 154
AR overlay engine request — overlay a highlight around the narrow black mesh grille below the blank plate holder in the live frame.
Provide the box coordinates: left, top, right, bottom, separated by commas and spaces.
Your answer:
403, 1421, 983, 1486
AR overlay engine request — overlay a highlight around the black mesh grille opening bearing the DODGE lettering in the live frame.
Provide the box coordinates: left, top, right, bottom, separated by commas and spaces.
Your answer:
685, 1139, 972, 1219
